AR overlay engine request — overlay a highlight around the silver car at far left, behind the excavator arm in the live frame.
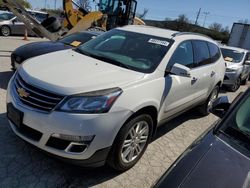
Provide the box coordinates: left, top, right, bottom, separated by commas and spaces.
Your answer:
0, 11, 47, 36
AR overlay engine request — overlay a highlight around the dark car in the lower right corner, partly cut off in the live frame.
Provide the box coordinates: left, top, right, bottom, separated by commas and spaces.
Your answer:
155, 88, 250, 188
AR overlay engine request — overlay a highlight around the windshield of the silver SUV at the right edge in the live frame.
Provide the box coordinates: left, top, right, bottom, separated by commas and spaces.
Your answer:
221, 48, 244, 63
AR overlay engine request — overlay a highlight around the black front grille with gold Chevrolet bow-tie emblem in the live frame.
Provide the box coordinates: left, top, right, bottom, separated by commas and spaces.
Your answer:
14, 74, 63, 112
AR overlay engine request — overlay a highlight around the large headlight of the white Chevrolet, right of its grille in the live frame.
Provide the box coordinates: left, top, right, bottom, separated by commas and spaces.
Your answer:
58, 88, 122, 113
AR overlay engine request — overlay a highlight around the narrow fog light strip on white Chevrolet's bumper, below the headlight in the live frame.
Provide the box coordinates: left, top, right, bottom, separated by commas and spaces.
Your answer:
51, 133, 95, 142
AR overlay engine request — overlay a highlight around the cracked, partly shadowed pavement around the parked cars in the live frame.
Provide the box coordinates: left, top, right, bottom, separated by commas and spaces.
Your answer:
0, 37, 249, 188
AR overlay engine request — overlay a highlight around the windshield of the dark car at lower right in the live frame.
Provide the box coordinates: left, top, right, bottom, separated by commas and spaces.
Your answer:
222, 90, 250, 146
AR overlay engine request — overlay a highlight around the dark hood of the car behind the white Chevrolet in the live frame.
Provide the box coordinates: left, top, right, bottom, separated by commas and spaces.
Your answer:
12, 41, 72, 62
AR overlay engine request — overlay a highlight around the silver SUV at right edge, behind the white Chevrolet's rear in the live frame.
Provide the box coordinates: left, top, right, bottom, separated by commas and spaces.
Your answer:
221, 46, 250, 92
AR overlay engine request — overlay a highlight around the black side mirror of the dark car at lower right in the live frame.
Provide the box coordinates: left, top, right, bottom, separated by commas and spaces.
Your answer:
210, 96, 231, 118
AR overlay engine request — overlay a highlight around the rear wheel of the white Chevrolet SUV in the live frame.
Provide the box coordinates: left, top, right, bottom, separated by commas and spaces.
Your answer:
199, 86, 220, 116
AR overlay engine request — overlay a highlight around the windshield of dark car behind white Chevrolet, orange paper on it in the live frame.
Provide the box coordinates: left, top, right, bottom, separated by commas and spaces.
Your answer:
59, 33, 96, 46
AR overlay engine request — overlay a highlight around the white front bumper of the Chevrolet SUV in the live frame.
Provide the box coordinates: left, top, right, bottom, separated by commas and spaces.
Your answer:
7, 75, 132, 163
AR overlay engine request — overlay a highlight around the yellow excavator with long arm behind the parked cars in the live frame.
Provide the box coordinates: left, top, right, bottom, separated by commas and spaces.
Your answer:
3, 0, 145, 41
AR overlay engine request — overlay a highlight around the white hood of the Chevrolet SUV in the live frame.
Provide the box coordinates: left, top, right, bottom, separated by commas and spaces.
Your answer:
19, 50, 145, 95
